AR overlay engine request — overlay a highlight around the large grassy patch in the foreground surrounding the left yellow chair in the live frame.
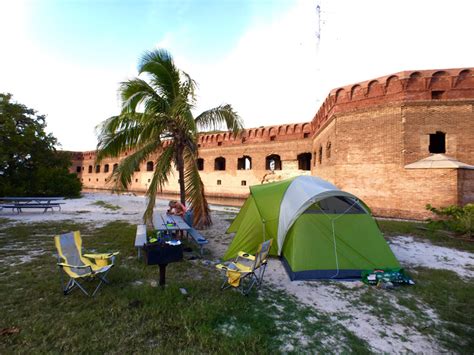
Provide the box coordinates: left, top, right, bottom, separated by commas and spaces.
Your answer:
0, 221, 368, 354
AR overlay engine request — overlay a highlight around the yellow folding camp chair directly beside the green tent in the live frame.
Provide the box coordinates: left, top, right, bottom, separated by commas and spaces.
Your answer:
216, 239, 273, 295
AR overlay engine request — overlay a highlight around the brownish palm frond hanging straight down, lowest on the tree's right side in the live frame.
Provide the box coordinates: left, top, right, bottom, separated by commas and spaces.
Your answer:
184, 147, 212, 228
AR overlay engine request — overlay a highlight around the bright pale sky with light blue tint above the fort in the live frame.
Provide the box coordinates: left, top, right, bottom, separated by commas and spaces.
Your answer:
0, 0, 474, 151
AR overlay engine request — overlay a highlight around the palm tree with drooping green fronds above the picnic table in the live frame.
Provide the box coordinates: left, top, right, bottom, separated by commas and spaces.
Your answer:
97, 49, 242, 226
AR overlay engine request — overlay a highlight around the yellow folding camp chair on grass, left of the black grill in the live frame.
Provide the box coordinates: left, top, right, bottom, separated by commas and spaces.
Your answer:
54, 231, 119, 296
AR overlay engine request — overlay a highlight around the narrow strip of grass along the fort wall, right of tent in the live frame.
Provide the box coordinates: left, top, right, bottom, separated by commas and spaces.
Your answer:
377, 219, 474, 252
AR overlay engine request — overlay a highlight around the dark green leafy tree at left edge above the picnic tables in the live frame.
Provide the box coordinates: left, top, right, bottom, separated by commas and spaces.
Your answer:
0, 94, 81, 197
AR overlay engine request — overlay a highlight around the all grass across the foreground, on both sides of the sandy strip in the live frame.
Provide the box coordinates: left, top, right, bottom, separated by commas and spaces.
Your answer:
0, 219, 474, 354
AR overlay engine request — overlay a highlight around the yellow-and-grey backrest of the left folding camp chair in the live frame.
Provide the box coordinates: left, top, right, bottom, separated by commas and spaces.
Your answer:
54, 231, 90, 277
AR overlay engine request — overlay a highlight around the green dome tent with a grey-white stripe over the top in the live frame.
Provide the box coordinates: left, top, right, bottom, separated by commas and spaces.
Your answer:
224, 176, 400, 280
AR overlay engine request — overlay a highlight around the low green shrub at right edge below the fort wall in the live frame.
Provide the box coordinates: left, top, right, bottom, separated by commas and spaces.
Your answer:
426, 203, 474, 237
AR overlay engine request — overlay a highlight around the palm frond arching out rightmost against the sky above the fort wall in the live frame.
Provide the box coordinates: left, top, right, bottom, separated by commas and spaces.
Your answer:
196, 104, 243, 135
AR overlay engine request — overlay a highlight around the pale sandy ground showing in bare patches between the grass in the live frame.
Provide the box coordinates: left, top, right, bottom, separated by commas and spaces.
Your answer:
0, 193, 474, 353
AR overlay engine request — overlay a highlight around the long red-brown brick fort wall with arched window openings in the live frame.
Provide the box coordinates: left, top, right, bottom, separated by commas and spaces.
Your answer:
72, 68, 474, 219
